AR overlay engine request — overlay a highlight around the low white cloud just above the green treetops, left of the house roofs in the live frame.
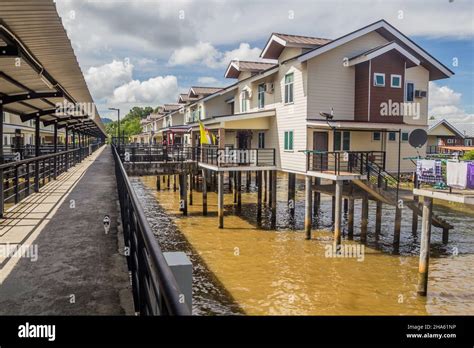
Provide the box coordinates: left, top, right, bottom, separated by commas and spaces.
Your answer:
109, 75, 178, 106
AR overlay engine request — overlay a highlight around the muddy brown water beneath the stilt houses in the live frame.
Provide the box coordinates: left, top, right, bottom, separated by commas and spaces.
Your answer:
133, 175, 474, 315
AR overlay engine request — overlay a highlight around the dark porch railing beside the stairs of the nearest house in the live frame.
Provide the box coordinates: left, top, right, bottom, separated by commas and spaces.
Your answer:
303, 150, 385, 175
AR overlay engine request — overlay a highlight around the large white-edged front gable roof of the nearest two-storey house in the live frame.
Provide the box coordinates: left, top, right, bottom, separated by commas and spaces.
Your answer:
298, 19, 454, 81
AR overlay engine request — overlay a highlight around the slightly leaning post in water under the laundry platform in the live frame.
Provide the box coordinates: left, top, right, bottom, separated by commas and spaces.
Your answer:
417, 197, 433, 296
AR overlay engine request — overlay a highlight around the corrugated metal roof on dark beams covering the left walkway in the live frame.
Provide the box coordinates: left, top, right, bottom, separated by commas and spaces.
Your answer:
0, 0, 105, 135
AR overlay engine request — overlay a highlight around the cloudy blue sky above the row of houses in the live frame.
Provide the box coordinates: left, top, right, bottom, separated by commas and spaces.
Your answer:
56, 0, 474, 132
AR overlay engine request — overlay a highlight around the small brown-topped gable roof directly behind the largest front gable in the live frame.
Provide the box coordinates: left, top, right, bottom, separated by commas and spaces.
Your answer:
260, 33, 331, 59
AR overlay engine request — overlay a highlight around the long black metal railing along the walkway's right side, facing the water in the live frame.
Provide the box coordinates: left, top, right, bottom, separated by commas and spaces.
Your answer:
112, 146, 191, 315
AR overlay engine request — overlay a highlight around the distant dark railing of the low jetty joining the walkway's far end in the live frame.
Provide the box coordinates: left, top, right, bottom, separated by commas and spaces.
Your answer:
118, 144, 199, 162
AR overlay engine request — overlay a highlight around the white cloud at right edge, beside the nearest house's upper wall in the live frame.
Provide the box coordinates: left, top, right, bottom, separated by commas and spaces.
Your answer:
428, 82, 474, 134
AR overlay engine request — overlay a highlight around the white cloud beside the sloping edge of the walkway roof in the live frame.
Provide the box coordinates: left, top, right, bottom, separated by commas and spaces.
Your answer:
84, 60, 133, 99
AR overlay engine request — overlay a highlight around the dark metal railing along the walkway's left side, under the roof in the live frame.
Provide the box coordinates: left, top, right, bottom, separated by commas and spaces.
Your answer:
0, 145, 99, 217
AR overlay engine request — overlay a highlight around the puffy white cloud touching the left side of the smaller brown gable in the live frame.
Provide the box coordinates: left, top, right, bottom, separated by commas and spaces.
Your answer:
168, 42, 268, 69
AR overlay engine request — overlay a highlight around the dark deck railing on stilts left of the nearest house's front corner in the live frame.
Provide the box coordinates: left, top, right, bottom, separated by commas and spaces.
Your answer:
199, 145, 275, 167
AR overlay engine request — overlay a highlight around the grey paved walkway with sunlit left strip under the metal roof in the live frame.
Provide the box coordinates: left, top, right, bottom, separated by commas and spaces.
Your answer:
0, 147, 133, 315
